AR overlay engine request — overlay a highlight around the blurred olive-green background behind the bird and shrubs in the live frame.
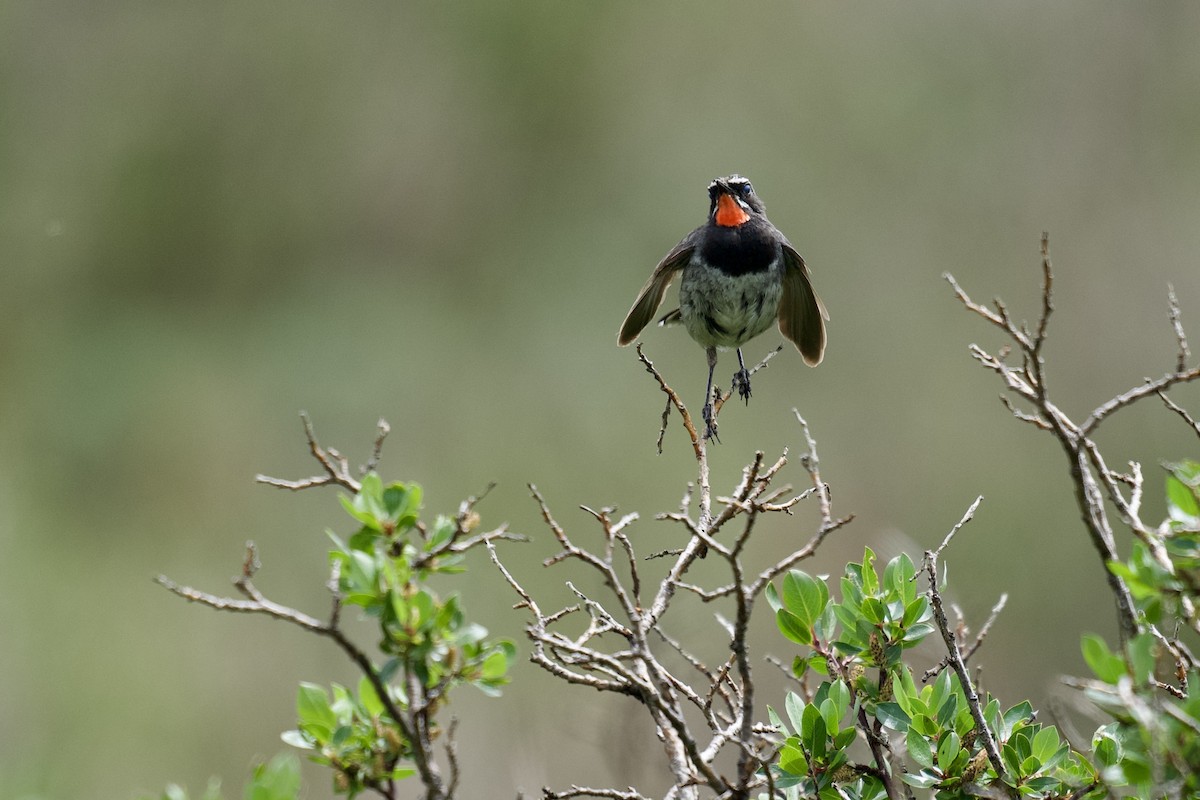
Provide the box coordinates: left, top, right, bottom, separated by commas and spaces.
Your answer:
0, 1, 1200, 799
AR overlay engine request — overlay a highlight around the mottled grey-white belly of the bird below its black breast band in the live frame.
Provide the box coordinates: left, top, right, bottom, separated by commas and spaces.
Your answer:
679, 249, 782, 348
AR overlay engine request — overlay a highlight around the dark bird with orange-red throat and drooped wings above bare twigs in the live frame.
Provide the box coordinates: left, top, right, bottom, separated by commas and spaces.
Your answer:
617, 175, 829, 441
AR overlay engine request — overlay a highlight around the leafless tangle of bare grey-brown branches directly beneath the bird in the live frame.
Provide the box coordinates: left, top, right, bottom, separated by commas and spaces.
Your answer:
485, 357, 849, 800
